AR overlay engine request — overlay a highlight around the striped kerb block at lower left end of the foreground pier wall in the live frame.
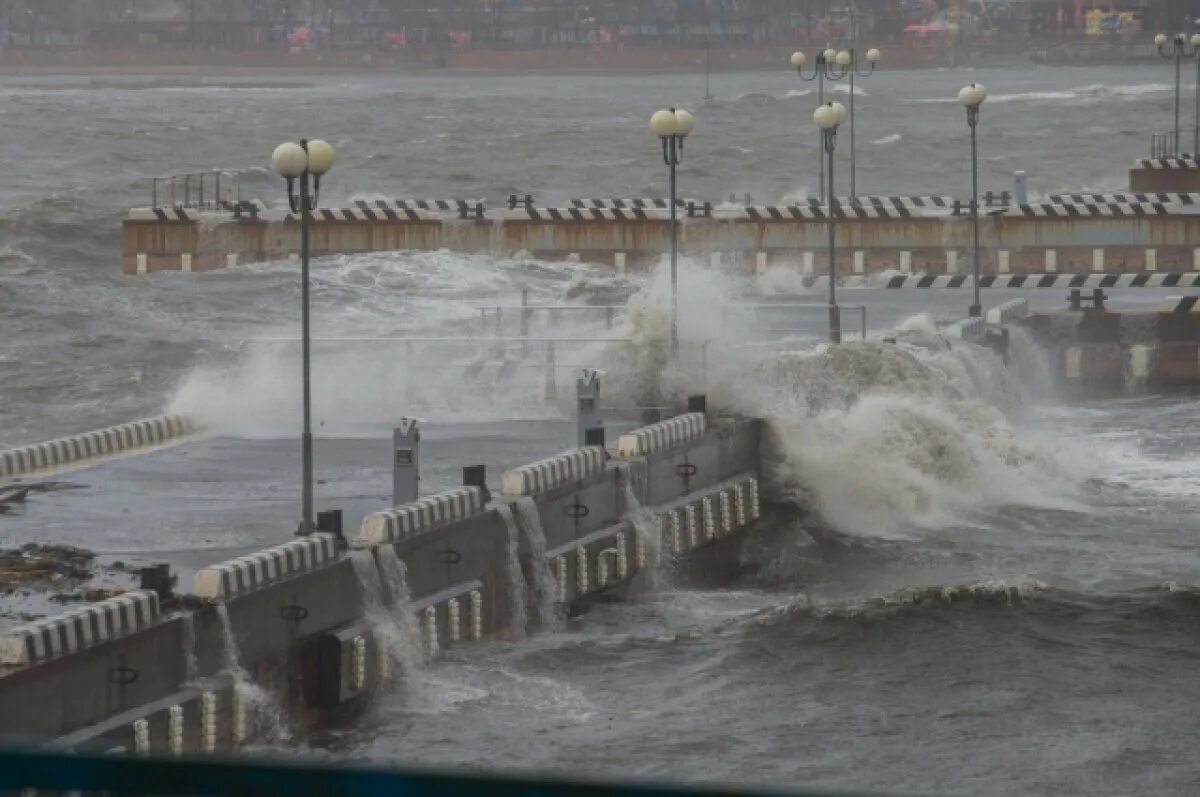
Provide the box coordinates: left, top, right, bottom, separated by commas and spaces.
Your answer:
0, 589, 158, 665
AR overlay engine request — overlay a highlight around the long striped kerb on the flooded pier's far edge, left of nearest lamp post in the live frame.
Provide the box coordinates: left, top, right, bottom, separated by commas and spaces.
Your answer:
0, 415, 199, 479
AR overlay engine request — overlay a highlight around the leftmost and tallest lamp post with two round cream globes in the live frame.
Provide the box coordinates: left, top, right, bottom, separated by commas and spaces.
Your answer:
271, 139, 334, 534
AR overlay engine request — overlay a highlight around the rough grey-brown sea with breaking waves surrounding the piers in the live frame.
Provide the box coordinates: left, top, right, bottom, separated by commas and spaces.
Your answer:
0, 67, 1200, 795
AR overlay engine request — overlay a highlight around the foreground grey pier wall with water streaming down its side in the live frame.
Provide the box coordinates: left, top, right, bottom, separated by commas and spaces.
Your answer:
0, 414, 761, 754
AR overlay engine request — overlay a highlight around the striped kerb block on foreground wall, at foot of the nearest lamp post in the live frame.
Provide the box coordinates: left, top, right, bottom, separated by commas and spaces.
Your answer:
194, 534, 338, 603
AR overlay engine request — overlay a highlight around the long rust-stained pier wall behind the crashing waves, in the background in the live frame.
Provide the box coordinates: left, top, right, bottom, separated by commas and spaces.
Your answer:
122, 193, 1200, 275
